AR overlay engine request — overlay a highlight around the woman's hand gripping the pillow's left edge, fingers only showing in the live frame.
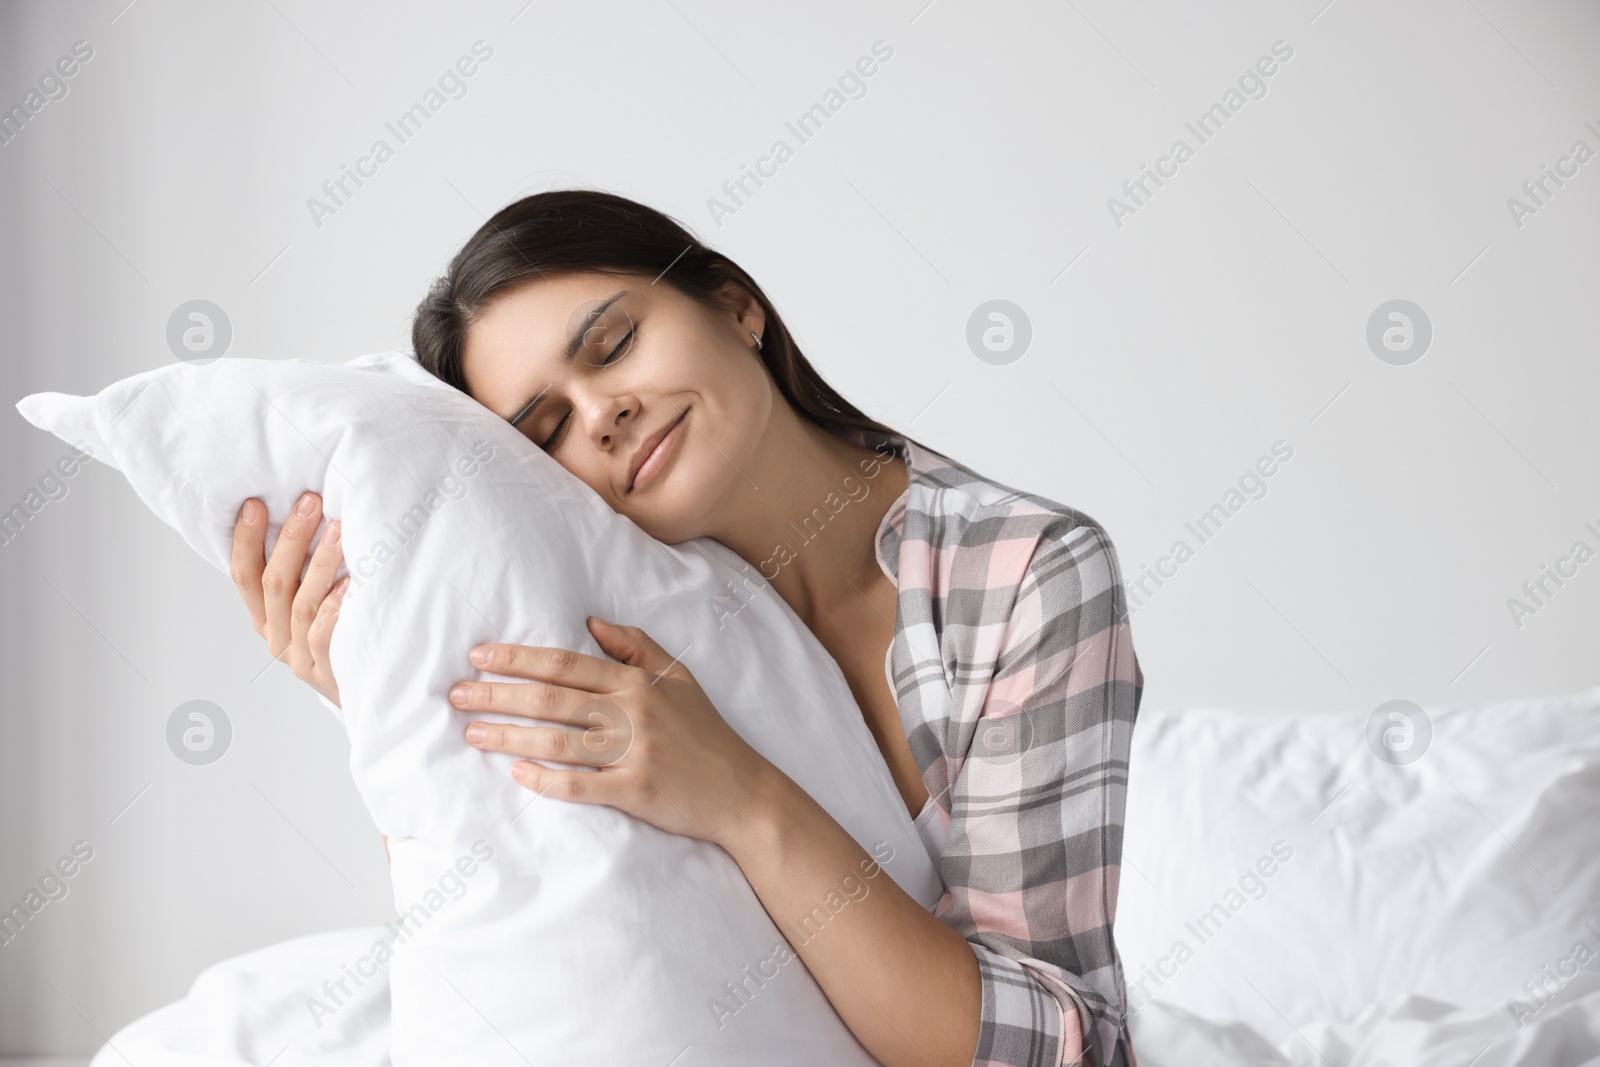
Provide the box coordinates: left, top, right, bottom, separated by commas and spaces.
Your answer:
229, 493, 350, 705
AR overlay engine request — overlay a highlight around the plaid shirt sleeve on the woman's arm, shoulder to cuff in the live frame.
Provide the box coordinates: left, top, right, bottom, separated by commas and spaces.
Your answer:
939, 522, 1144, 1067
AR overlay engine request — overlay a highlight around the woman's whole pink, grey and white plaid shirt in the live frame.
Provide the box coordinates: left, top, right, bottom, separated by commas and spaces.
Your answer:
848, 434, 1144, 1067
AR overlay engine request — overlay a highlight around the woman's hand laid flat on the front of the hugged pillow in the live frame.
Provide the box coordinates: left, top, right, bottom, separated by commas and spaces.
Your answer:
450, 617, 776, 845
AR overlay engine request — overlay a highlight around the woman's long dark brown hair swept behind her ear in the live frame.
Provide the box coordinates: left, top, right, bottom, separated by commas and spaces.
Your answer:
411, 189, 906, 437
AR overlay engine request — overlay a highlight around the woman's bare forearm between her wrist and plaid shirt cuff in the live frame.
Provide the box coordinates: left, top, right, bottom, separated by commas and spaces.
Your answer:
729, 766, 981, 1067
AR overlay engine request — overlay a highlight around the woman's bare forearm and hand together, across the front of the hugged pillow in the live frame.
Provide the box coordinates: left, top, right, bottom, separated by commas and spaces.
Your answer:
450, 619, 979, 1067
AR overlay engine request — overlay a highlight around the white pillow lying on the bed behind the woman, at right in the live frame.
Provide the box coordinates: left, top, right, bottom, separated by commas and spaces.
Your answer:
1117, 686, 1600, 1062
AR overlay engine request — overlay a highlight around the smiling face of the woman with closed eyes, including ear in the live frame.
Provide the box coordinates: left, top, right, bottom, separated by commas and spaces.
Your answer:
461, 274, 774, 544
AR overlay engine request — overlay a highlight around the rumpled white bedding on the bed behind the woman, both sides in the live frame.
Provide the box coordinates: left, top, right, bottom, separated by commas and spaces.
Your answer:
93, 686, 1600, 1067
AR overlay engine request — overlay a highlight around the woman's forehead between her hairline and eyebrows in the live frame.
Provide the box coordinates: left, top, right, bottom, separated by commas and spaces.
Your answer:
461, 272, 659, 414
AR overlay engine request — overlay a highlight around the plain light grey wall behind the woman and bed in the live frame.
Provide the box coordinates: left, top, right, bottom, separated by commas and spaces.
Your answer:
0, 0, 1600, 1053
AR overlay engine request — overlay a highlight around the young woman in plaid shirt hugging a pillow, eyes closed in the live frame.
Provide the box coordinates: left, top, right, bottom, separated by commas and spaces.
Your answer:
234, 190, 1144, 1067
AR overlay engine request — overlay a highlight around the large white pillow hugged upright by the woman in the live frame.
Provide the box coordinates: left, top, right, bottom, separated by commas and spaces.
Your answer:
18, 352, 941, 1067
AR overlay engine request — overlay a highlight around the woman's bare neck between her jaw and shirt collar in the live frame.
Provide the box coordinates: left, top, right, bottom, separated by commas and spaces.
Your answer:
707, 405, 907, 629
